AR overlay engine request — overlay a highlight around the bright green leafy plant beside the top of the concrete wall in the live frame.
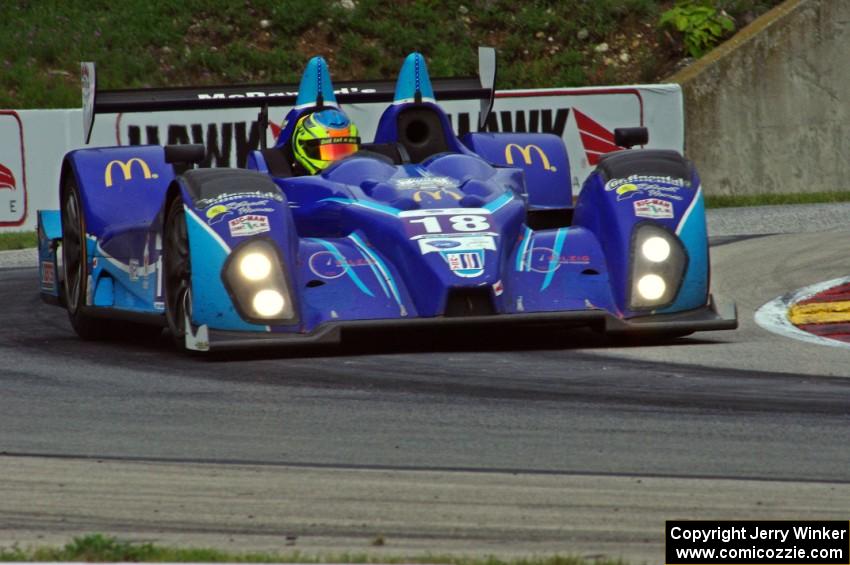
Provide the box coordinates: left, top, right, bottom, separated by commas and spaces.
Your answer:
658, 0, 735, 59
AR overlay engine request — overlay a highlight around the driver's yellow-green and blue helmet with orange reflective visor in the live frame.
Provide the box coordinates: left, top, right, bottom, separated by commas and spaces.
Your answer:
292, 109, 360, 174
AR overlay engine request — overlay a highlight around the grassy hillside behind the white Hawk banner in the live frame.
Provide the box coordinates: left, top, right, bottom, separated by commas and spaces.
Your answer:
0, 0, 781, 108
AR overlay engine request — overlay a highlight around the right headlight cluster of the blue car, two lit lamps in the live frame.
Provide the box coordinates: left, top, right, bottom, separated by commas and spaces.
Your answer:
629, 222, 688, 310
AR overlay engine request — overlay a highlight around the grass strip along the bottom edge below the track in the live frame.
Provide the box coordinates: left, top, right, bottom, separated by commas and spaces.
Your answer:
0, 534, 624, 565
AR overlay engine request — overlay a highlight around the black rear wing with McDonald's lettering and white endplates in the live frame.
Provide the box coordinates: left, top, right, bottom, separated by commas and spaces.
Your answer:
81, 47, 496, 143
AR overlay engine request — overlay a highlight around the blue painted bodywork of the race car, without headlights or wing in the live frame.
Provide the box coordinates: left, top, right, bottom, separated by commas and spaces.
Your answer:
39, 53, 724, 348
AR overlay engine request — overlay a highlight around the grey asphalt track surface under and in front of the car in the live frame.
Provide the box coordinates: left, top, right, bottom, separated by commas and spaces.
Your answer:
0, 207, 850, 560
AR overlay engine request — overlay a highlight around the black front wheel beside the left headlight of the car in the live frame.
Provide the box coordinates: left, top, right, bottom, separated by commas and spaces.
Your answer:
163, 196, 192, 350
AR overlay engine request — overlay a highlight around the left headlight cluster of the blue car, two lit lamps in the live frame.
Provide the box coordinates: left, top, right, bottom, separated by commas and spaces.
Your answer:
222, 239, 298, 325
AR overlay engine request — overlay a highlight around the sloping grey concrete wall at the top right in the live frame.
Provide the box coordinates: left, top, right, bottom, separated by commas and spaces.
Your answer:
668, 0, 850, 194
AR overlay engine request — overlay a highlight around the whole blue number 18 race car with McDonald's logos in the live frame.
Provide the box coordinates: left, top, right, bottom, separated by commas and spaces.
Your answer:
38, 49, 737, 351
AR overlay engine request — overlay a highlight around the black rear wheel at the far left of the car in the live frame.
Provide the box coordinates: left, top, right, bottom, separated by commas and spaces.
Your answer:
61, 175, 108, 340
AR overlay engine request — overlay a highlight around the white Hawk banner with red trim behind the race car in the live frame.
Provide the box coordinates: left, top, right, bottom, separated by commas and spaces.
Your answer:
0, 84, 684, 232
